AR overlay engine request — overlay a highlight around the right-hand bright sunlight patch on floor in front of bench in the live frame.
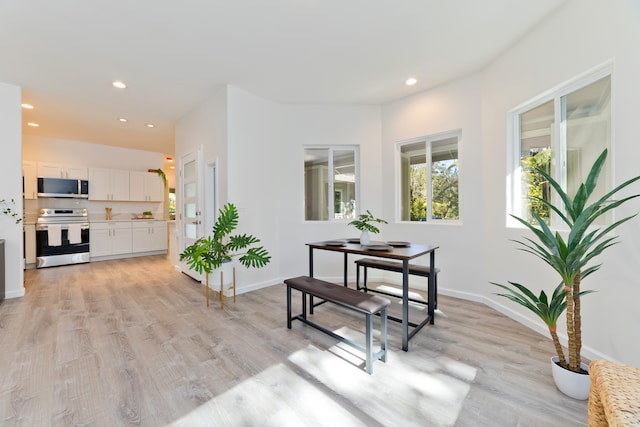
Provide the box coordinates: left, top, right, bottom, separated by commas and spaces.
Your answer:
289, 346, 475, 426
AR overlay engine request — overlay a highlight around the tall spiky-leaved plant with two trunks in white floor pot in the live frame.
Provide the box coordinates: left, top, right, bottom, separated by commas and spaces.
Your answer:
492, 149, 640, 399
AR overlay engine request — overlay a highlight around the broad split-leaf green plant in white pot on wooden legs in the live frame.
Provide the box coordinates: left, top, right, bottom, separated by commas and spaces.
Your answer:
180, 203, 271, 306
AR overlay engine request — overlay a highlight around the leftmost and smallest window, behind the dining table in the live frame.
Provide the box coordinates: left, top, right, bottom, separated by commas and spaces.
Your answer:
304, 146, 359, 221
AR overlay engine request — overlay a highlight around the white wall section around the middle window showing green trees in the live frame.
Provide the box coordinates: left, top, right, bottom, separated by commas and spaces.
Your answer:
382, 75, 482, 299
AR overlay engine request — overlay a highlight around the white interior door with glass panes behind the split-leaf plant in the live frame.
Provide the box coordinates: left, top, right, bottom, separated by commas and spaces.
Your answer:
179, 151, 203, 281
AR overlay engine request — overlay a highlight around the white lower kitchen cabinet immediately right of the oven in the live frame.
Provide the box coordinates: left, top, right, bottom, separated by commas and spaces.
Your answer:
89, 221, 132, 257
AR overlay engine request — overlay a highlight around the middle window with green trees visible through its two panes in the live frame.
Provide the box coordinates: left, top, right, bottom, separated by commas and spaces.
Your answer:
398, 132, 460, 221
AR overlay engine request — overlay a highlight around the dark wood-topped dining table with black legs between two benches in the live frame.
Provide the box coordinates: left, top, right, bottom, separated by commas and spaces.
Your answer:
307, 239, 438, 351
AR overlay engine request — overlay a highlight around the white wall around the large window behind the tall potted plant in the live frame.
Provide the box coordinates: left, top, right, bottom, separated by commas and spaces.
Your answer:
479, 0, 640, 366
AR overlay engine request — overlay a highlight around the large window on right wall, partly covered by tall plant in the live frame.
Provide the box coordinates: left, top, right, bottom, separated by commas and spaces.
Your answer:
511, 69, 612, 226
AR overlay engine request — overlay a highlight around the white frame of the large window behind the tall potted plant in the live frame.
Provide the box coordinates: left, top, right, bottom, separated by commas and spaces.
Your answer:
506, 61, 614, 230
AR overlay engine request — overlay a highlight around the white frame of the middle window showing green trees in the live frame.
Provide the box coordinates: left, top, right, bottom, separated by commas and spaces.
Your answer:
395, 129, 463, 224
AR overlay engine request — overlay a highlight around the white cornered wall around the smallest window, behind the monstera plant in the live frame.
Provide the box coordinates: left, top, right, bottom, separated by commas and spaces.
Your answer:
176, 86, 382, 292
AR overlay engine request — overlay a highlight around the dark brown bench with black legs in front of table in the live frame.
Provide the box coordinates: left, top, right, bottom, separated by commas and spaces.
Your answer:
284, 276, 390, 375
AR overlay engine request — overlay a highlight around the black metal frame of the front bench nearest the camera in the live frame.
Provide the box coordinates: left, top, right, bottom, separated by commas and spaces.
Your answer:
284, 276, 389, 375
